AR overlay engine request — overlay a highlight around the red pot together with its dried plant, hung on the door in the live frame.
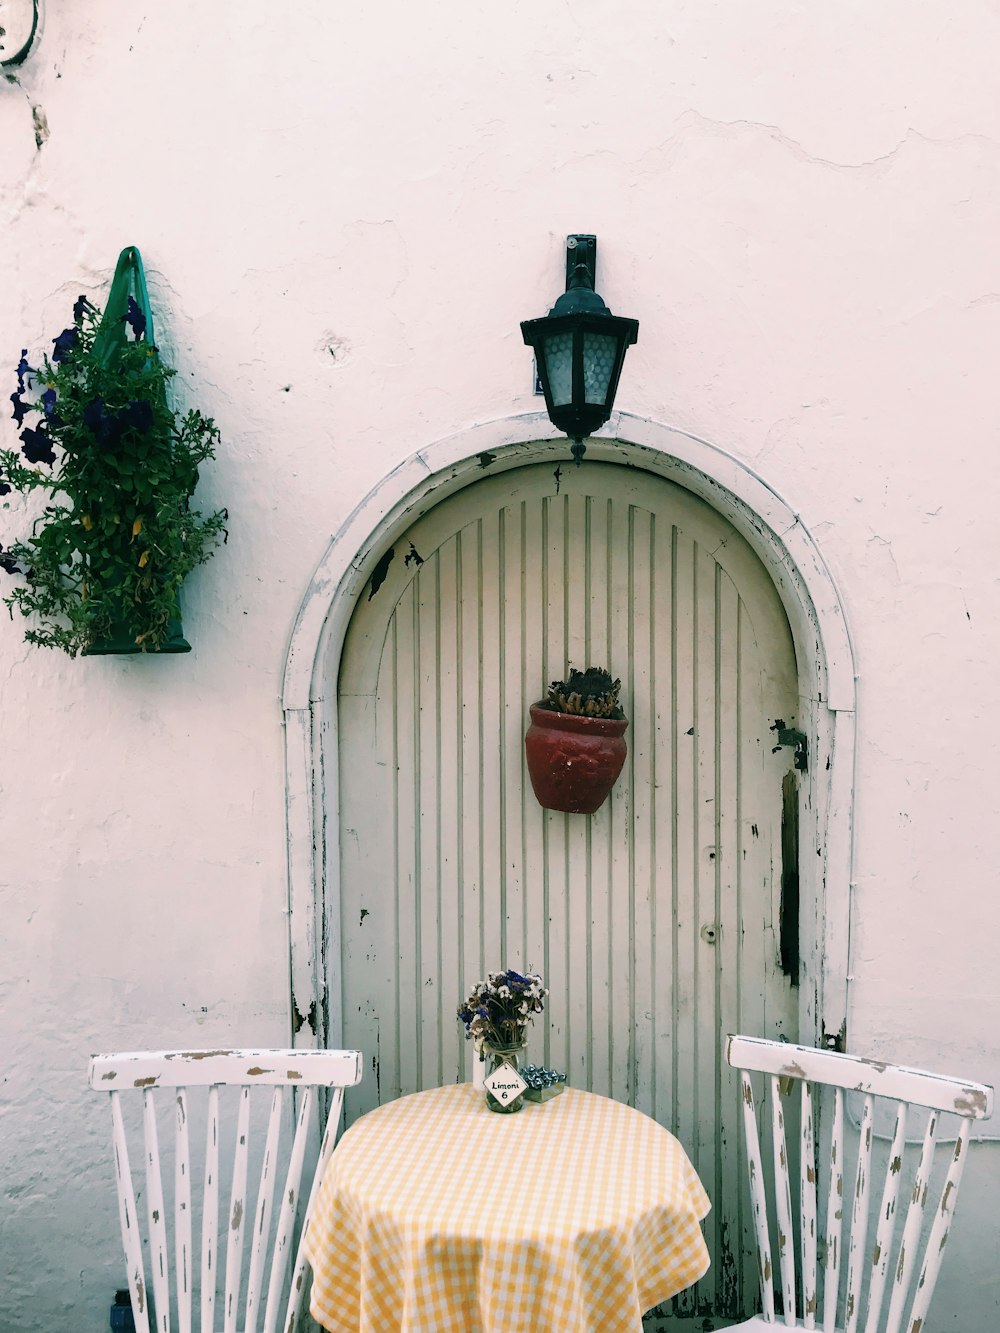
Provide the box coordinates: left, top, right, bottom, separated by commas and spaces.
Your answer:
524, 667, 628, 814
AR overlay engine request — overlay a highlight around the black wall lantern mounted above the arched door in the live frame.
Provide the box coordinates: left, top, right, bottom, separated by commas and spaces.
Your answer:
521, 236, 639, 463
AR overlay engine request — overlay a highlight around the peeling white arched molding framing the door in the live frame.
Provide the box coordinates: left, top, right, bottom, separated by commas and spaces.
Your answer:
281, 412, 856, 1046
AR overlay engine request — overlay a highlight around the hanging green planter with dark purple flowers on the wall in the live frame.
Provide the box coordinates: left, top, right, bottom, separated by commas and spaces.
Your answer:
0, 247, 225, 657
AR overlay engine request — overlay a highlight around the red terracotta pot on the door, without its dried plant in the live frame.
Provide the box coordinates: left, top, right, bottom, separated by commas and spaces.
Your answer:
524, 704, 628, 814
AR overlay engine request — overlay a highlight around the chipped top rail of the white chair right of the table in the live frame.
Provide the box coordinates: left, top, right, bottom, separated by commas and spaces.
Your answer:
725, 1036, 993, 1120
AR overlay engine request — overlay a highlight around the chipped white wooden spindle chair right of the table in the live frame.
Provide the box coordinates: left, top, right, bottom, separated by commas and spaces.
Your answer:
725, 1037, 993, 1333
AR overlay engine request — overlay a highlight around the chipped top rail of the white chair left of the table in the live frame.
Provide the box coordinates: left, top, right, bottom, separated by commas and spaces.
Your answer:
89, 1049, 363, 1092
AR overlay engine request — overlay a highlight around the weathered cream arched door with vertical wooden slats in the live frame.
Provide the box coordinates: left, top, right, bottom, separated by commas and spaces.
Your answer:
337, 463, 797, 1314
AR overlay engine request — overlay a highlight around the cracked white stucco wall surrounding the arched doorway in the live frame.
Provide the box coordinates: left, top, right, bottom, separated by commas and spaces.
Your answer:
0, 0, 1000, 1333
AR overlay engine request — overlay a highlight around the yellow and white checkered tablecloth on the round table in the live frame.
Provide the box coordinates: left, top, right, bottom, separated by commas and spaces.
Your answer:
305, 1084, 711, 1333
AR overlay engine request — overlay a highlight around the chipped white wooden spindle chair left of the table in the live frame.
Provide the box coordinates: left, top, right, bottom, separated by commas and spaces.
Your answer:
89, 1050, 361, 1333
